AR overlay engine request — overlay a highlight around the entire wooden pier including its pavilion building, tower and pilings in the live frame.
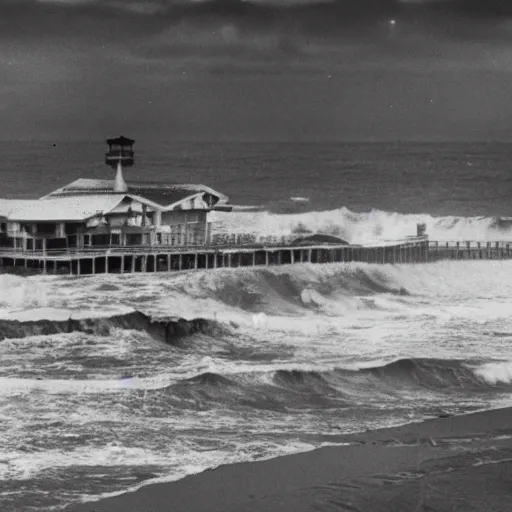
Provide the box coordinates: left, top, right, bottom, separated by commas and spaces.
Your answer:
0, 135, 512, 276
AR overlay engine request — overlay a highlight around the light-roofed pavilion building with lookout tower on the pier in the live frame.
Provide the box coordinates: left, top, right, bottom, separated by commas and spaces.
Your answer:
0, 136, 231, 252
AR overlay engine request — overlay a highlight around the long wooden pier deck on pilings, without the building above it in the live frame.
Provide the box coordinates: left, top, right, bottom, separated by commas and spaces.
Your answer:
0, 237, 512, 276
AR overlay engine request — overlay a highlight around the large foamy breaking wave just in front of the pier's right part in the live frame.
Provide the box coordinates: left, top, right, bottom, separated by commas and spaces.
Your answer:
167, 261, 512, 321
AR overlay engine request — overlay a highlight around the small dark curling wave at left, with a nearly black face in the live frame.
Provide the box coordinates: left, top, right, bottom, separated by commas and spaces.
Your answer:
0, 311, 227, 345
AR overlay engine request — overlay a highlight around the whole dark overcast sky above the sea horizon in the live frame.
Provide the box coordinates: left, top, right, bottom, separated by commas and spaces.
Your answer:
0, 0, 512, 141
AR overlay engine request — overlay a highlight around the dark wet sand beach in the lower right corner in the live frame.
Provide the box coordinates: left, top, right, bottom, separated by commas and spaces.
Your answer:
70, 408, 512, 512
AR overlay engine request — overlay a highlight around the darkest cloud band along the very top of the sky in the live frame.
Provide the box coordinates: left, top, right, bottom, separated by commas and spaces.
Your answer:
0, 0, 512, 39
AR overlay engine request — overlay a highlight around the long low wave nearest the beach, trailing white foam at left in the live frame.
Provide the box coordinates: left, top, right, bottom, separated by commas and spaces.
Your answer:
7, 358, 496, 402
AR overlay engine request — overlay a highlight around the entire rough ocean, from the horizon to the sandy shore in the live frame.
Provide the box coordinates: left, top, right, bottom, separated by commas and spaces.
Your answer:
0, 141, 512, 512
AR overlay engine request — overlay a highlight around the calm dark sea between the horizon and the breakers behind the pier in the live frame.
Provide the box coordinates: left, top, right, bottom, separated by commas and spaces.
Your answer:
0, 140, 512, 216
